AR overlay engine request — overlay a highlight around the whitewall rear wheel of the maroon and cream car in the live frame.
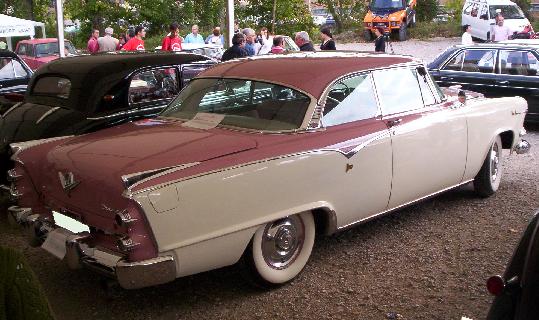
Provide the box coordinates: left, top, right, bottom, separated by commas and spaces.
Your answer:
242, 212, 315, 288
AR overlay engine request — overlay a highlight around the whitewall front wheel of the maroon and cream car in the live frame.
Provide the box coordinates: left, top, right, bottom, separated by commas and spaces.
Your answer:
473, 136, 502, 198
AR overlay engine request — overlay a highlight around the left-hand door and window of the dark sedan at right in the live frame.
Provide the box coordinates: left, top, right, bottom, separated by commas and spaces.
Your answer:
437, 48, 496, 93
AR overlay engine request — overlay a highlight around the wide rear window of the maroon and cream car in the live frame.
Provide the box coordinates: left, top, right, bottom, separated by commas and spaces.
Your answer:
161, 78, 311, 131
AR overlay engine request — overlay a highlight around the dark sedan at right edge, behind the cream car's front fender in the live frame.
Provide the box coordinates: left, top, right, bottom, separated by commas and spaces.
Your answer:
428, 43, 539, 123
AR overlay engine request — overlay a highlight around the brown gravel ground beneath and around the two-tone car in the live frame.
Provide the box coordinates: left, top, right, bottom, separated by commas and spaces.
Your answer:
0, 41, 539, 320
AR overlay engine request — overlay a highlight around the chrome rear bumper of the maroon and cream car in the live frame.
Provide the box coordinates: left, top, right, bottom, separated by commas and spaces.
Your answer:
8, 206, 176, 289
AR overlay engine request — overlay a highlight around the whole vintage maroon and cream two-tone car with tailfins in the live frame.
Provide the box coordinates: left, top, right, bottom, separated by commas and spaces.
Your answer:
9, 52, 529, 288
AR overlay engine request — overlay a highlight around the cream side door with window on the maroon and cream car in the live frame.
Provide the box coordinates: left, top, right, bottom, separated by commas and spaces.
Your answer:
374, 67, 467, 209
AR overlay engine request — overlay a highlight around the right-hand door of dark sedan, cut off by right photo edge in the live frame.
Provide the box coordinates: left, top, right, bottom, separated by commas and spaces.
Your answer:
496, 49, 539, 119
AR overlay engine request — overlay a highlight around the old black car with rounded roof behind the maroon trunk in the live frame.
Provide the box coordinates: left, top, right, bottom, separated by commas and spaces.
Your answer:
0, 52, 216, 181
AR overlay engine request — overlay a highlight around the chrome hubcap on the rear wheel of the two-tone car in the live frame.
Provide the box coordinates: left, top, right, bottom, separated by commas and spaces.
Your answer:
262, 216, 305, 269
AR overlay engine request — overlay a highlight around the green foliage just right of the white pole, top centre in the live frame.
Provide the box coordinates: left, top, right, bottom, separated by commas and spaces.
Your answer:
236, 0, 317, 37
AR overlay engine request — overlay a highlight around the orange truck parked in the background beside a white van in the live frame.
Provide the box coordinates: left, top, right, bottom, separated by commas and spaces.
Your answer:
363, 0, 416, 41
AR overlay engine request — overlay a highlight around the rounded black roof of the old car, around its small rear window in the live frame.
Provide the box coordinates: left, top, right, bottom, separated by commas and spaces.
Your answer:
25, 52, 212, 112
